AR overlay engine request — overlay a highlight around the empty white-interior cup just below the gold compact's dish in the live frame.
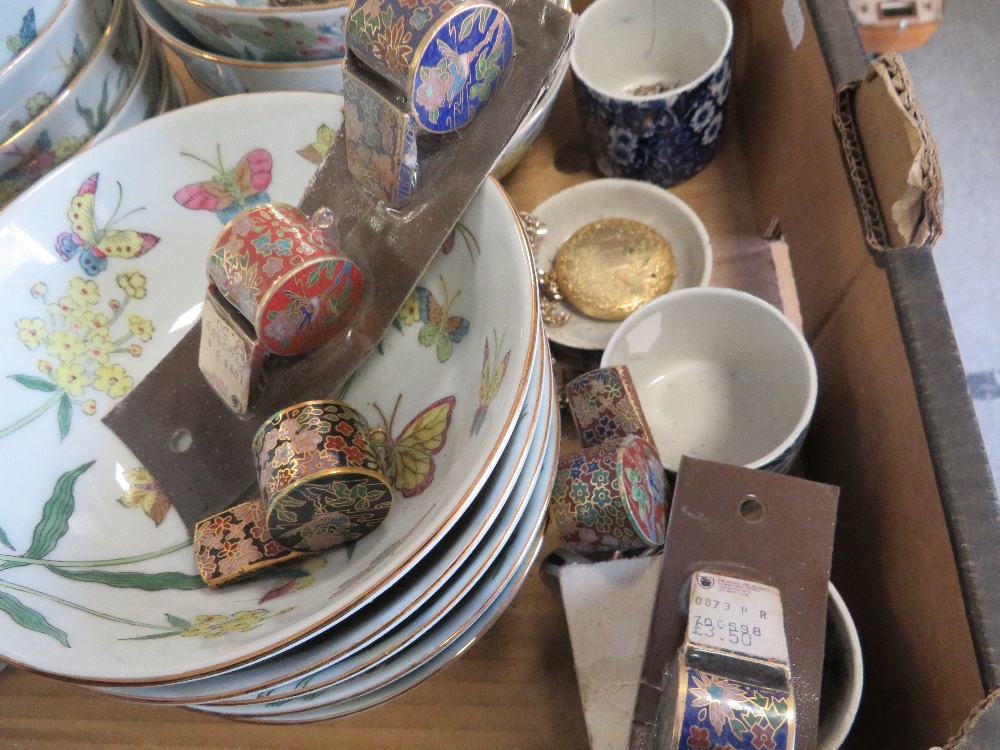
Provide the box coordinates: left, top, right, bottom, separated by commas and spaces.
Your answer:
601, 287, 817, 471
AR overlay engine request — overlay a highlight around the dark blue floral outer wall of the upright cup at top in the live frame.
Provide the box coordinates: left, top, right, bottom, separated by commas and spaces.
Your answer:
573, 54, 732, 187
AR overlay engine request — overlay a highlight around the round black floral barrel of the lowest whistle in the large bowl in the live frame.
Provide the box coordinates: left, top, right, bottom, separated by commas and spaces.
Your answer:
253, 401, 392, 551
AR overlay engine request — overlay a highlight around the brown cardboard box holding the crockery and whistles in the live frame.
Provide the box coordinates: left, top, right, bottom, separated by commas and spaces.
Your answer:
0, 0, 1000, 750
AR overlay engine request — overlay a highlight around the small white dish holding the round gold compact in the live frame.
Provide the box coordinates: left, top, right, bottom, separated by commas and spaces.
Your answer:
532, 178, 712, 350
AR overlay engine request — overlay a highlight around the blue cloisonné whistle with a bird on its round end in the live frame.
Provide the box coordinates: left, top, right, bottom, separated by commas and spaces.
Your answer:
344, 0, 514, 207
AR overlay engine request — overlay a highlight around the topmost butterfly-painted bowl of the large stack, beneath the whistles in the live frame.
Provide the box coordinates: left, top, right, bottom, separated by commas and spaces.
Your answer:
0, 92, 540, 685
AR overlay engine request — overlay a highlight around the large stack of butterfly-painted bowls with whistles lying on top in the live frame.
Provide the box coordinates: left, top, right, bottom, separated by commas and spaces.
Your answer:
0, 93, 558, 722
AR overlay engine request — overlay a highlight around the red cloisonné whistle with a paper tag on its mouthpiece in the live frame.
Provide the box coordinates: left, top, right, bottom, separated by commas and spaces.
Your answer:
198, 203, 363, 413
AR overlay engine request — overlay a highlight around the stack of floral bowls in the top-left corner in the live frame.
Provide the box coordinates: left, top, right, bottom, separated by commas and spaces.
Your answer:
0, 0, 180, 207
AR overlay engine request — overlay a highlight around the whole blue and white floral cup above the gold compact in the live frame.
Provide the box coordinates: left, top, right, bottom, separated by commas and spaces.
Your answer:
570, 0, 733, 187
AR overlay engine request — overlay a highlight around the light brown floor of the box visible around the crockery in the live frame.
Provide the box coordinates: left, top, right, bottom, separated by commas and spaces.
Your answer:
0, 57, 784, 750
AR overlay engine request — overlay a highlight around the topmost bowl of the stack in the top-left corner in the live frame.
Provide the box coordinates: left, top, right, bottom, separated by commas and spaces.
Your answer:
0, 0, 112, 142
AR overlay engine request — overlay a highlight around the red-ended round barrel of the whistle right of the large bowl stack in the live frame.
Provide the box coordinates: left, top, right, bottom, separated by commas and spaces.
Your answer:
551, 435, 667, 555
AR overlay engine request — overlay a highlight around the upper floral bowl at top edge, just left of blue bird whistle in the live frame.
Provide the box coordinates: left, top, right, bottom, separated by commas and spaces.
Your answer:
153, 0, 351, 62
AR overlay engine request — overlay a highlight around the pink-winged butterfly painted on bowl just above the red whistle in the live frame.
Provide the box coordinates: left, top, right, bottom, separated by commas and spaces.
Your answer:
174, 145, 273, 224
